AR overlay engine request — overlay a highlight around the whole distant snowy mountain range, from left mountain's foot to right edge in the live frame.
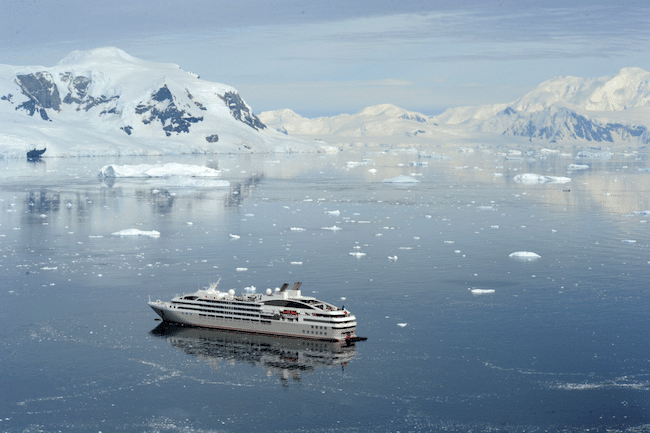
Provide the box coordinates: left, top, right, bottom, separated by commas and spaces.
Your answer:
260, 68, 650, 147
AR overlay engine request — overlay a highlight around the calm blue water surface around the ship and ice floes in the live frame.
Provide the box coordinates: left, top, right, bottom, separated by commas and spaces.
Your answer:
0, 148, 650, 432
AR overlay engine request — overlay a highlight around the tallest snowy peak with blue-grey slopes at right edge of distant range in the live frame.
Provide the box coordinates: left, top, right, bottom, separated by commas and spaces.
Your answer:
436, 68, 650, 144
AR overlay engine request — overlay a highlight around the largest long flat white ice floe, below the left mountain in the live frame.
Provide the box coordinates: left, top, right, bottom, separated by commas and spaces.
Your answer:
99, 162, 221, 178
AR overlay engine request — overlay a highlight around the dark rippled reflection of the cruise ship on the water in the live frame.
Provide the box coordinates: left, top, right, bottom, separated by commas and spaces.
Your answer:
151, 322, 356, 383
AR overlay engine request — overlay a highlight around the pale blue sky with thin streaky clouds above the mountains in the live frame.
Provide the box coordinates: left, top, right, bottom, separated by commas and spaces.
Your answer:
0, 0, 650, 117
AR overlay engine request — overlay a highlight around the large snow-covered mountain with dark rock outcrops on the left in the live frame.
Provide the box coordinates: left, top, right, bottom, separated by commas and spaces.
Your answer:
0, 48, 323, 156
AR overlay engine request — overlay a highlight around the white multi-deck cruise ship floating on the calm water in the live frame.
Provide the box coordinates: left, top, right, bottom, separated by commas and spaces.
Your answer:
149, 282, 365, 343
